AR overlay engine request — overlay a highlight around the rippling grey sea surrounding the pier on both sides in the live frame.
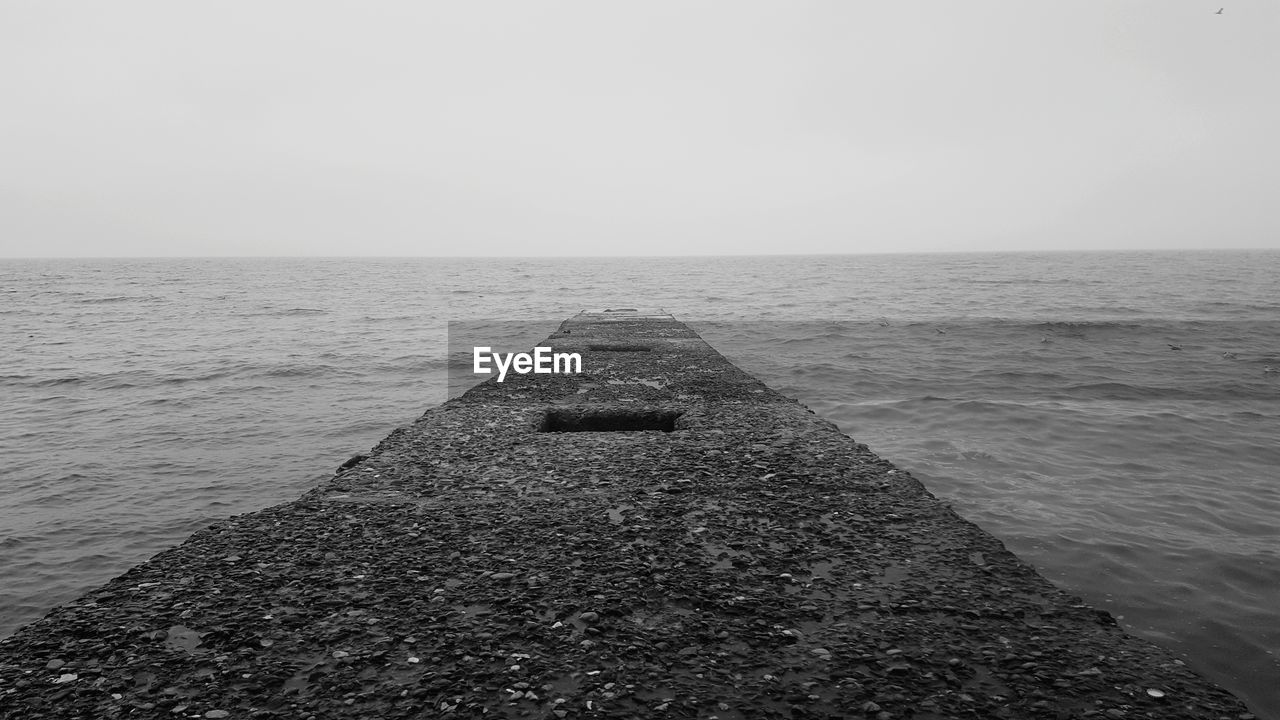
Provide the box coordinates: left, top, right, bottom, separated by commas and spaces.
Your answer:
0, 250, 1280, 719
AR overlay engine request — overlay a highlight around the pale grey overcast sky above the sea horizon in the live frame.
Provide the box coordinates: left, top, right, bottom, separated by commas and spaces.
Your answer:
0, 0, 1280, 258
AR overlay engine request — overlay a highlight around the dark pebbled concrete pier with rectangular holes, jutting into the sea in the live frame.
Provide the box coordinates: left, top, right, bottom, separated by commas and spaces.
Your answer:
0, 309, 1249, 720
